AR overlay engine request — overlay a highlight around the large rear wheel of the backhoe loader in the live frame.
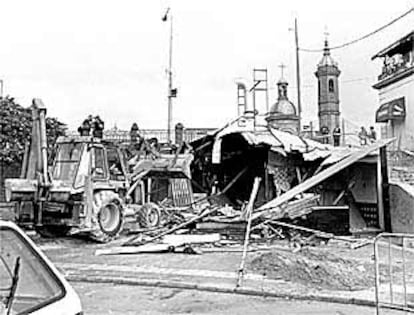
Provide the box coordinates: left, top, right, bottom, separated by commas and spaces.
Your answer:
90, 193, 124, 243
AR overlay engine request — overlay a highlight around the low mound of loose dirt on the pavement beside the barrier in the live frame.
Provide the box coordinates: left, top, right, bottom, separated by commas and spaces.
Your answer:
252, 248, 375, 291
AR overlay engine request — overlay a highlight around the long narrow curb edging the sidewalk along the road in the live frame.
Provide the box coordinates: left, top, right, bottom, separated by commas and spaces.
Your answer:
66, 275, 376, 307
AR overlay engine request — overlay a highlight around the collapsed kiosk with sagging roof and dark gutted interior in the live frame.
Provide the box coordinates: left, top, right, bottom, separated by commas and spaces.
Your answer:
192, 116, 392, 234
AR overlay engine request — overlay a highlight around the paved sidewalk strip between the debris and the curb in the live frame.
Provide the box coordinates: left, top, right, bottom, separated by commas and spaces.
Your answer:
57, 263, 375, 306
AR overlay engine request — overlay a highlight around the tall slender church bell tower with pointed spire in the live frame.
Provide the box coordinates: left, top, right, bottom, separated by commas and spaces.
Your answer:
315, 38, 341, 135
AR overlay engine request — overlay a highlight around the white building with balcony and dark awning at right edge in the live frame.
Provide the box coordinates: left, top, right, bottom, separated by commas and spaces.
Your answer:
372, 32, 414, 151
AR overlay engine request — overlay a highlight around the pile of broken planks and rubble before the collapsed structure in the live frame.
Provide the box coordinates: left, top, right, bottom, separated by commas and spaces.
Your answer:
97, 186, 351, 255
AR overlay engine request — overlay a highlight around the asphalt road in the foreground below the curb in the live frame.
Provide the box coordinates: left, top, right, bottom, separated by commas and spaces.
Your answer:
72, 282, 390, 315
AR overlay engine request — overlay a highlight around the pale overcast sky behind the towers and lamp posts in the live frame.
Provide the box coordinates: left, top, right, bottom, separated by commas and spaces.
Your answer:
0, 0, 414, 129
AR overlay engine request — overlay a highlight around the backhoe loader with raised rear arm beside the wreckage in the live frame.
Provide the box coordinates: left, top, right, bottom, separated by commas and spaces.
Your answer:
5, 99, 192, 242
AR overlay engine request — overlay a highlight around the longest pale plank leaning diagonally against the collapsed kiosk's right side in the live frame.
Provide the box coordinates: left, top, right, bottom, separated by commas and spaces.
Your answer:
253, 138, 395, 220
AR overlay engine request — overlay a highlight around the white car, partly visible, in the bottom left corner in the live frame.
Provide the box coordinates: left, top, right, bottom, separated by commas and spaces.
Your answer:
0, 220, 83, 315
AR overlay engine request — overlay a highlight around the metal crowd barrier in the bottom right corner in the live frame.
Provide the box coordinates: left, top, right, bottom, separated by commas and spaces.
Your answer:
374, 233, 414, 315
